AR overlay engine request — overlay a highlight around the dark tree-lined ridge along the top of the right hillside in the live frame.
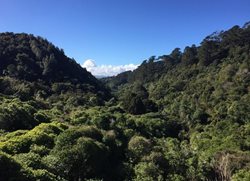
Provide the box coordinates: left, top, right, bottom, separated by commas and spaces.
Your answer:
102, 23, 250, 90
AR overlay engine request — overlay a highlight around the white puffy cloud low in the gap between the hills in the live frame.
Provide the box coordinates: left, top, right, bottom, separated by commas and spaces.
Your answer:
82, 59, 138, 76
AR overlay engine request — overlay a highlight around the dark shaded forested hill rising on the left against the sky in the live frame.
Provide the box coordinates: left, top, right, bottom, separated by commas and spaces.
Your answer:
0, 33, 97, 84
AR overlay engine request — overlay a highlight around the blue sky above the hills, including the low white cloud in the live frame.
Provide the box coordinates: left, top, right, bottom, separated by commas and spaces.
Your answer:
0, 0, 250, 76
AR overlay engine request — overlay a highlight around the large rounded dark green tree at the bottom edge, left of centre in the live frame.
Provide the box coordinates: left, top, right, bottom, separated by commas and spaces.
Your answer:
51, 137, 107, 180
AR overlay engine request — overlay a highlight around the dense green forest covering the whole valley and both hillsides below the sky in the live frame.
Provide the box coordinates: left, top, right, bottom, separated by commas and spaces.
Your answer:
0, 23, 250, 181
